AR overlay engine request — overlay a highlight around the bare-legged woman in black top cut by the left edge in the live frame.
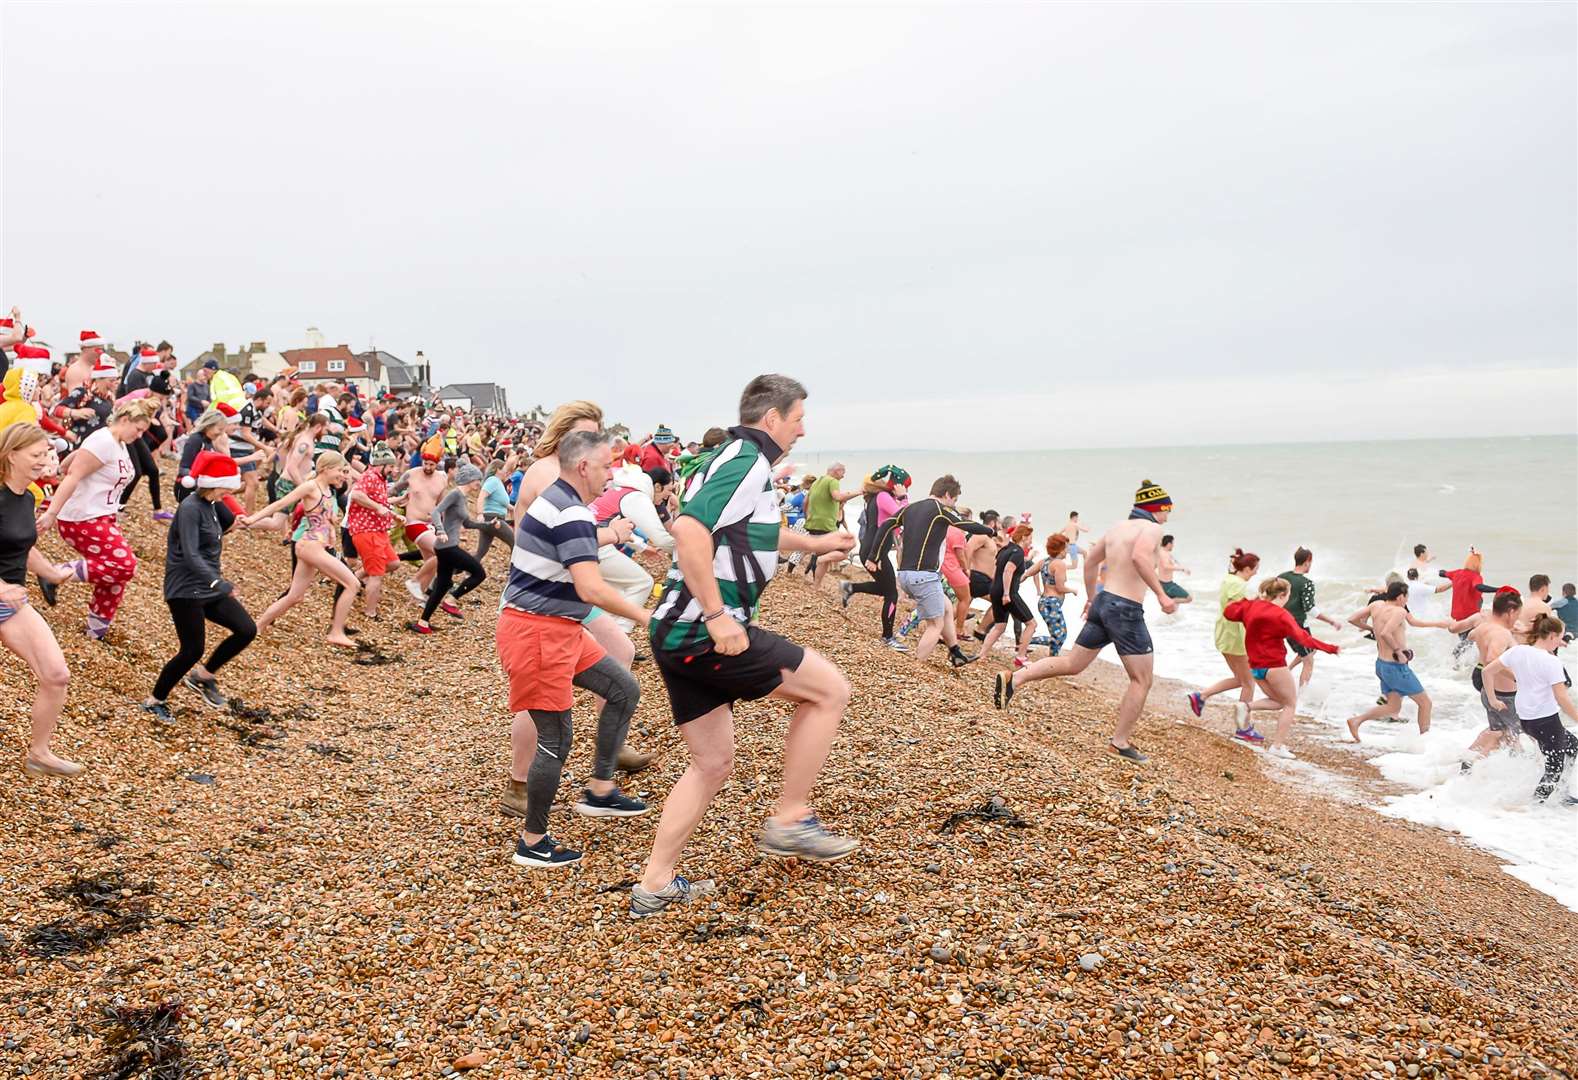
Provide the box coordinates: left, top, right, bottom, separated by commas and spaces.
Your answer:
0, 423, 82, 777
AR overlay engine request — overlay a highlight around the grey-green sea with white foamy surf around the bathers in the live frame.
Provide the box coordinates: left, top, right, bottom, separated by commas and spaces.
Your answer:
792, 428, 1578, 909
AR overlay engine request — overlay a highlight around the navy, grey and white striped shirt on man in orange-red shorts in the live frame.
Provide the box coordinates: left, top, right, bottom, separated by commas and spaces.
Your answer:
503, 480, 596, 622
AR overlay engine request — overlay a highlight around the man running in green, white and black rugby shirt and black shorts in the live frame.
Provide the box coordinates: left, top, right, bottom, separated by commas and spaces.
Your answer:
630, 374, 858, 917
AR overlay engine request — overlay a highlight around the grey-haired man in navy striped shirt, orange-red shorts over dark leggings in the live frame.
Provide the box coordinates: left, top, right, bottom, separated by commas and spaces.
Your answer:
495, 431, 649, 868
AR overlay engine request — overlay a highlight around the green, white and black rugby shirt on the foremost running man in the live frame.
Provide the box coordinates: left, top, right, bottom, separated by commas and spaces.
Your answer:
649, 426, 783, 655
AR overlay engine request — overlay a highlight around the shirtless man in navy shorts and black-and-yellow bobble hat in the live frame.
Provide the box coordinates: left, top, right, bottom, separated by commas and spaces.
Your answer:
993, 480, 1179, 763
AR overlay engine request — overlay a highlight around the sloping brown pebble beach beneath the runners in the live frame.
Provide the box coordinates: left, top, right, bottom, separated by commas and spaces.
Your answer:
0, 494, 1578, 1080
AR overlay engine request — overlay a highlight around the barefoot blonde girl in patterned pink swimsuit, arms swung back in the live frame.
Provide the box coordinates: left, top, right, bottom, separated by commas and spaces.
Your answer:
241, 450, 361, 649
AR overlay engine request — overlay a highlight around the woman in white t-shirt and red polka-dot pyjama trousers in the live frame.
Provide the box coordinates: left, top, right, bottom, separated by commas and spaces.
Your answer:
38, 396, 155, 641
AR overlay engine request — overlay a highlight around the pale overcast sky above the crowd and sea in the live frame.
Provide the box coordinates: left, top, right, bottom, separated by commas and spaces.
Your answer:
0, 0, 1578, 448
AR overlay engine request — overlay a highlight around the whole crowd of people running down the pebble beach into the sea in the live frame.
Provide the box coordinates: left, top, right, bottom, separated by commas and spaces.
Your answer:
0, 311, 1578, 916
